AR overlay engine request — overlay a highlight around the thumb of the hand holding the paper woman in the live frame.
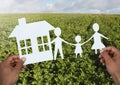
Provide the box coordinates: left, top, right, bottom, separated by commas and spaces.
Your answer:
101, 51, 113, 66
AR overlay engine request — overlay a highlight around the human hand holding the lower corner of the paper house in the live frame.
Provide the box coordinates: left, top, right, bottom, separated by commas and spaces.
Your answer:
0, 55, 25, 85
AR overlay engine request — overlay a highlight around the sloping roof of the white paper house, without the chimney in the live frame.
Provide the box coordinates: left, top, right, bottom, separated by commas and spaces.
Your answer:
9, 21, 55, 39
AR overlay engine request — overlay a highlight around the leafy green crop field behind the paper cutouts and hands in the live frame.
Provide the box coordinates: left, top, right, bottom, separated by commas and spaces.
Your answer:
0, 14, 120, 85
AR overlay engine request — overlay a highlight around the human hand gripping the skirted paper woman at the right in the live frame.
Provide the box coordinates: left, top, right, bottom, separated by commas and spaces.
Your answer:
99, 46, 120, 85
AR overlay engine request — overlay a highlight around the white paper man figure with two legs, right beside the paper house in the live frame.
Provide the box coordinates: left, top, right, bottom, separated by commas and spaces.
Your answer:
51, 28, 68, 60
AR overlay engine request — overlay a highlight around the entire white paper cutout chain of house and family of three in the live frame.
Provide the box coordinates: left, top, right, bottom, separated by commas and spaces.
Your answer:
9, 18, 108, 64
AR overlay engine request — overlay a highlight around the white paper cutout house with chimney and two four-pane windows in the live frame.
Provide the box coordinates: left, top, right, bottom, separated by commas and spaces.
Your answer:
9, 18, 55, 64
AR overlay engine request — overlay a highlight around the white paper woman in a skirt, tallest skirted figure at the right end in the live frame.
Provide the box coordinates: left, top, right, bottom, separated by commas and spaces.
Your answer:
86, 23, 108, 54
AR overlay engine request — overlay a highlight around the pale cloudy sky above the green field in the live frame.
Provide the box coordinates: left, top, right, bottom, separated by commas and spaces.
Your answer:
0, 0, 120, 14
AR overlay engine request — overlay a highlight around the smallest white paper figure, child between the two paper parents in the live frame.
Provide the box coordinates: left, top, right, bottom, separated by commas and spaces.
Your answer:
71, 35, 86, 58
